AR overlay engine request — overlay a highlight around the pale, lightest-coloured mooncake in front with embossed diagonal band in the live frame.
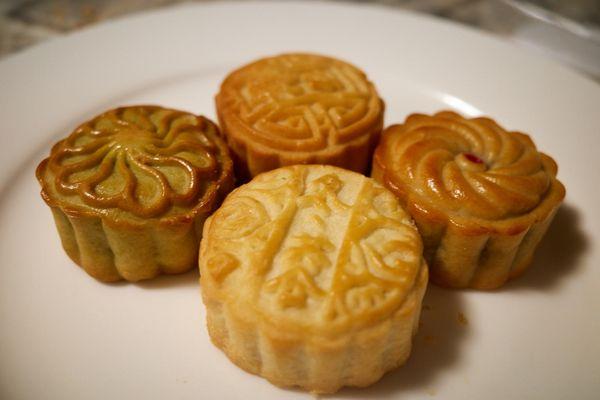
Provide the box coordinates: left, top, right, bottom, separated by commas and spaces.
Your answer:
200, 165, 427, 393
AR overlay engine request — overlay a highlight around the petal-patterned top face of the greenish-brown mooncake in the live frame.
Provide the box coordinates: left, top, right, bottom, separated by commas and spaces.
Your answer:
48, 106, 230, 217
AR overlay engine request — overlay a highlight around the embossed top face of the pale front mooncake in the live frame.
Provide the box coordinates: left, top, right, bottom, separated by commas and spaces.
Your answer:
201, 166, 422, 331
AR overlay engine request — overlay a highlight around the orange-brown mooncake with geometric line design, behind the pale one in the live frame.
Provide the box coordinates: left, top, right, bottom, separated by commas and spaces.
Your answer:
216, 54, 384, 178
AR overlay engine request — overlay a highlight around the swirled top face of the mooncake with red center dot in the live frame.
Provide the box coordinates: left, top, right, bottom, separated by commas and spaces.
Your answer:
379, 112, 556, 220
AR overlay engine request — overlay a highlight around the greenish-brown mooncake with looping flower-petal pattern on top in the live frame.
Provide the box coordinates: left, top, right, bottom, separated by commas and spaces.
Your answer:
36, 106, 234, 282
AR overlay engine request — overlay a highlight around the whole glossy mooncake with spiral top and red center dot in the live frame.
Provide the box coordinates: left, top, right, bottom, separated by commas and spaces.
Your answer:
372, 111, 565, 289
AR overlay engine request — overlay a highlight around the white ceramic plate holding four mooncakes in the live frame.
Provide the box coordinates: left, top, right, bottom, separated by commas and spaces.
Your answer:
0, 2, 600, 400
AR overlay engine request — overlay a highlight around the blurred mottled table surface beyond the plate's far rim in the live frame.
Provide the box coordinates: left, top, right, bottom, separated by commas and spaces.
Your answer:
0, 0, 600, 81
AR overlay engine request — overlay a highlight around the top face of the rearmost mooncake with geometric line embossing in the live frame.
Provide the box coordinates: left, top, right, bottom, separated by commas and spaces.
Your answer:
217, 54, 383, 152
